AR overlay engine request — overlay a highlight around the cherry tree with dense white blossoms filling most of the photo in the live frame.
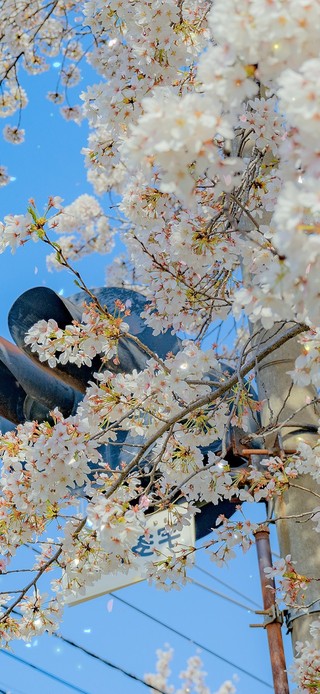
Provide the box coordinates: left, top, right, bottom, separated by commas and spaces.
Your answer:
0, 0, 320, 693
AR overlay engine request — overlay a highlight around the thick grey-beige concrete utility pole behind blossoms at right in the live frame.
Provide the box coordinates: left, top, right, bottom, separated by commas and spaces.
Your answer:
255, 324, 320, 648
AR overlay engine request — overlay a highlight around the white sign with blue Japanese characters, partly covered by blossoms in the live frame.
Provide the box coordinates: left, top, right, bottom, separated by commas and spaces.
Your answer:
66, 504, 195, 607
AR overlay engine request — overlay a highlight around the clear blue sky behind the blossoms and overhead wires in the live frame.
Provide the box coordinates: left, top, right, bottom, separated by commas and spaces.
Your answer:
0, 59, 291, 694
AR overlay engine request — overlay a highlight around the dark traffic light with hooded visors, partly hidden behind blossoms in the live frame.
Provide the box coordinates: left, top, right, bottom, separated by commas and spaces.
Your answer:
0, 287, 254, 539
